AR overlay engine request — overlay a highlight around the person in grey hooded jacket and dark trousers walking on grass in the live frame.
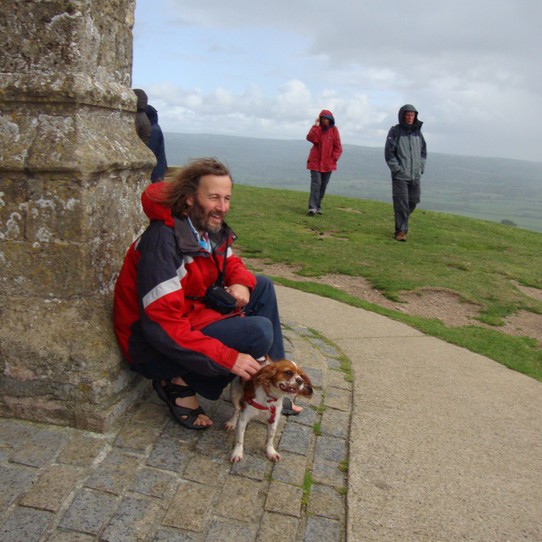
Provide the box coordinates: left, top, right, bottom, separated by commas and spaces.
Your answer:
384, 104, 427, 242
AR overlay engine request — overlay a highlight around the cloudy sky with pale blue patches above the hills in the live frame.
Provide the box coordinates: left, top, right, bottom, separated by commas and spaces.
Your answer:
133, 0, 542, 161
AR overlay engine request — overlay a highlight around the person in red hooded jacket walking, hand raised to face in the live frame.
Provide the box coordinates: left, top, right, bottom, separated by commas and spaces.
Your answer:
307, 109, 343, 216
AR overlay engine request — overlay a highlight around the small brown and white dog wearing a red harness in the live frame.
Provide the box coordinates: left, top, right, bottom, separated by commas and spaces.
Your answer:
225, 359, 312, 463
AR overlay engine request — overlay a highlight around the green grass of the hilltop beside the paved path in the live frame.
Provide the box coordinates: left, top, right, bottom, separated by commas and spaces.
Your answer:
228, 185, 542, 381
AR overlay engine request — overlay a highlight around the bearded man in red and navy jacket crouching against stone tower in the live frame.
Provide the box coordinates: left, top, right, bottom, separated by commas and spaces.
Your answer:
113, 158, 284, 429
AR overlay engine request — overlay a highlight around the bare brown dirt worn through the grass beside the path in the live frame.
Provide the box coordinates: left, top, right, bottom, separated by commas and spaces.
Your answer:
243, 256, 542, 345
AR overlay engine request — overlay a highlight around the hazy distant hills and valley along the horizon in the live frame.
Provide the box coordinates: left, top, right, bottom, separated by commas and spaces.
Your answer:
164, 133, 542, 232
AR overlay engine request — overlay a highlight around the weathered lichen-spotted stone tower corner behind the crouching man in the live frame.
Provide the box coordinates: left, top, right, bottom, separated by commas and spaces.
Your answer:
0, 0, 154, 431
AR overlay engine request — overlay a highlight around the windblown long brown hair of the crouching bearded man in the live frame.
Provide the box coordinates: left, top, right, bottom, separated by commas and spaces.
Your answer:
160, 158, 233, 217
